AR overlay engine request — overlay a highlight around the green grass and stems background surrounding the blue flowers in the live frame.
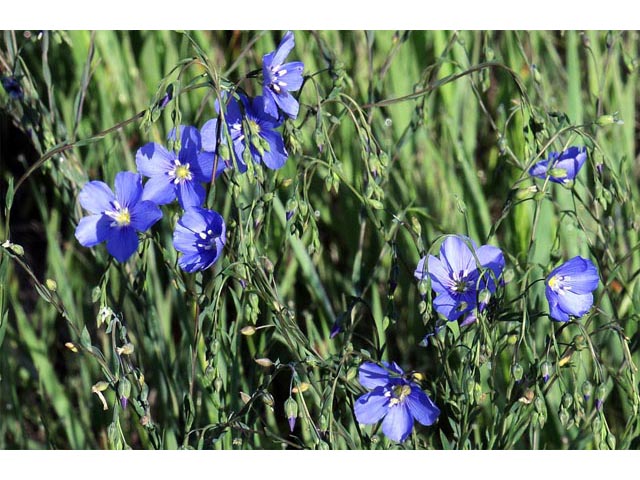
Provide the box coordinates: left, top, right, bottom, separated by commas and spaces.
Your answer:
0, 31, 640, 449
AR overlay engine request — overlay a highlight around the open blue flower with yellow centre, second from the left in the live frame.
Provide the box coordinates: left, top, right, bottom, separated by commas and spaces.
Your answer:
136, 125, 214, 209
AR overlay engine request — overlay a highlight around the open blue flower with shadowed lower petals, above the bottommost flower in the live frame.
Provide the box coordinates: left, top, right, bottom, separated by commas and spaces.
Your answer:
414, 236, 505, 325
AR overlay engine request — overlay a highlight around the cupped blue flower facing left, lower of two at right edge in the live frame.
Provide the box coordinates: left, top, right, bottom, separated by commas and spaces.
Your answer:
544, 256, 599, 322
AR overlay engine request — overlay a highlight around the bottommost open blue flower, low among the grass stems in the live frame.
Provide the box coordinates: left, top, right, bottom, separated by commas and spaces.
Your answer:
354, 362, 440, 442
